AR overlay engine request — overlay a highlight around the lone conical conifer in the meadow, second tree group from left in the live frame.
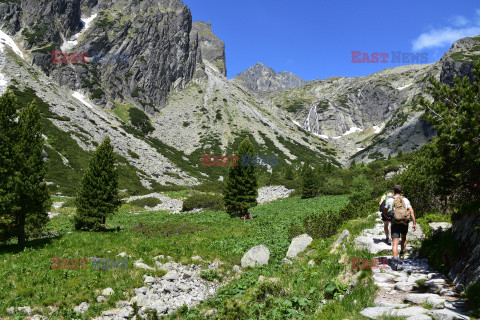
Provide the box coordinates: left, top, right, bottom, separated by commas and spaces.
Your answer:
75, 137, 121, 230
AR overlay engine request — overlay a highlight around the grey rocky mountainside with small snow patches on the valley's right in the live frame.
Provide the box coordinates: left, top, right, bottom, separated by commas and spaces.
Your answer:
264, 37, 480, 164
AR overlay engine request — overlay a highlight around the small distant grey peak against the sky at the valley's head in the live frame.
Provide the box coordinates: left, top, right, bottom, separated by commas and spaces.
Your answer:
233, 62, 307, 94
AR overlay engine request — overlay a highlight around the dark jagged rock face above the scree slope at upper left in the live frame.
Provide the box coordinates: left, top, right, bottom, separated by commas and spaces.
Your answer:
0, 0, 201, 112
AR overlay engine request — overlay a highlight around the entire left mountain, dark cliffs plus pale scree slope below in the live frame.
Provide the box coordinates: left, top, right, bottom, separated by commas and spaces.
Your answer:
0, 0, 336, 192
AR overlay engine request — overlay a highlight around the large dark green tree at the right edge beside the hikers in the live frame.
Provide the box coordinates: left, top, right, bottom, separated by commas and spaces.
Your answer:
402, 63, 480, 212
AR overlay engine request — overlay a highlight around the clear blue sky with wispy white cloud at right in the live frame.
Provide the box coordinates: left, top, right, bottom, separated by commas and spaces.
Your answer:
183, 0, 480, 80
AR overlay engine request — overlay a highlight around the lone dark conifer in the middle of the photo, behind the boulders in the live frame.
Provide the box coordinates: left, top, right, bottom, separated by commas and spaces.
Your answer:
224, 138, 258, 216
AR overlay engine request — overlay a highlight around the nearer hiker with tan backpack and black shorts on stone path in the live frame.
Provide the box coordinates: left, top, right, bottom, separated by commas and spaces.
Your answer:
383, 185, 417, 270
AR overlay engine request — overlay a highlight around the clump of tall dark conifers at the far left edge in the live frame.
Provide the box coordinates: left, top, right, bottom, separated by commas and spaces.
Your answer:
0, 91, 50, 247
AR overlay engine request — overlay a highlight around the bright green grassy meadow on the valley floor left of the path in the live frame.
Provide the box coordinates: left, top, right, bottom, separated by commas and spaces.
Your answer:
0, 195, 382, 319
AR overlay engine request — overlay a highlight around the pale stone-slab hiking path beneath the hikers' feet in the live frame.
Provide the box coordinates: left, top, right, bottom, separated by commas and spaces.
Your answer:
355, 212, 470, 320
